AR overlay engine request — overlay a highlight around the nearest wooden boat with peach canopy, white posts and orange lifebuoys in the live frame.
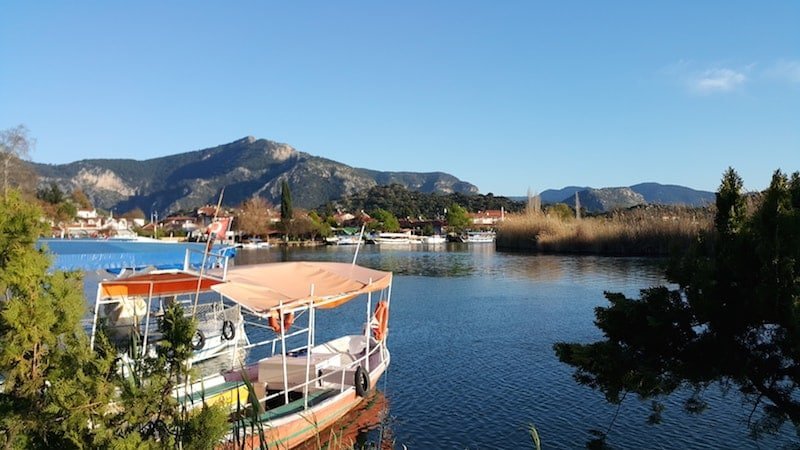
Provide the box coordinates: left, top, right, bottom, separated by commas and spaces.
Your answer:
214, 262, 392, 448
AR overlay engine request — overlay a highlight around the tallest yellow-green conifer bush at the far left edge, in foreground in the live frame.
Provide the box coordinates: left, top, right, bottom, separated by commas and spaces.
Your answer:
0, 190, 113, 448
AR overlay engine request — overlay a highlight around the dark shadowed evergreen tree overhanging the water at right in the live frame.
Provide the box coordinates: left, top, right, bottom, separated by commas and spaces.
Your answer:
554, 169, 800, 442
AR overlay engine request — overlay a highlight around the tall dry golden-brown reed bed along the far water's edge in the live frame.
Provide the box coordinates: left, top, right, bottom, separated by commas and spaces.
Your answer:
497, 207, 714, 256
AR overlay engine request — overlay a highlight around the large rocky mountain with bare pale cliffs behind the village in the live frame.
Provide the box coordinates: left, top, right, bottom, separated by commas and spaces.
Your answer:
34, 136, 478, 212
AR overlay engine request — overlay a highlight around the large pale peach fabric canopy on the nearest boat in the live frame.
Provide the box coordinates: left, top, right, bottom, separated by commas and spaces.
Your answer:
212, 261, 392, 313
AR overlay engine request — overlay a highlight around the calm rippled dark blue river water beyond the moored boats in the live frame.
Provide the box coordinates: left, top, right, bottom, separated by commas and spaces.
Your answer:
84, 244, 794, 449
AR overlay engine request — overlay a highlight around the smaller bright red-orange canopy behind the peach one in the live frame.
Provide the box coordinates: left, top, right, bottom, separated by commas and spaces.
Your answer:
100, 272, 222, 297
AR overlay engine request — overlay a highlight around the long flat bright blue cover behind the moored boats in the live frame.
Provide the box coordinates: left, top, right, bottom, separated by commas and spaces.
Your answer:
37, 239, 235, 271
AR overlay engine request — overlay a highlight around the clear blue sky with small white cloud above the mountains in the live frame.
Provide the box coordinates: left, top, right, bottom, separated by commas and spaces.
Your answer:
0, 1, 800, 195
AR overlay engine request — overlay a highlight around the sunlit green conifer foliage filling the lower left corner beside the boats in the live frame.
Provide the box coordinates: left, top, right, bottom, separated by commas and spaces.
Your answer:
0, 190, 225, 448
